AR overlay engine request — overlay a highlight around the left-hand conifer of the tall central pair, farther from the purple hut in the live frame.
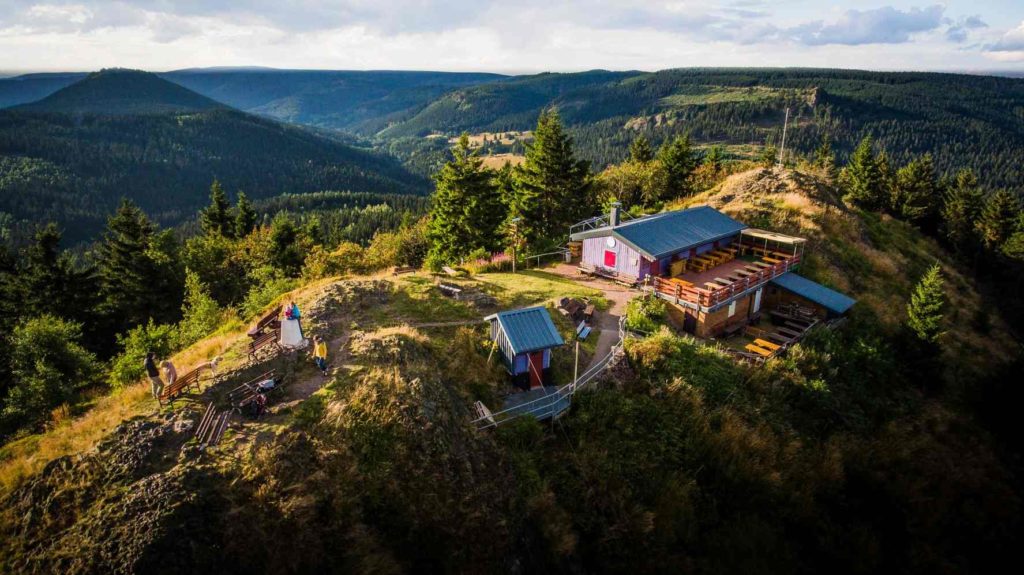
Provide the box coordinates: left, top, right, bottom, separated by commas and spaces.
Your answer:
428, 134, 506, 264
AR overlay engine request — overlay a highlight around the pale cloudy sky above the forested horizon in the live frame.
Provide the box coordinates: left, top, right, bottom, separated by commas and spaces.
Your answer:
0, 0, 1024, 73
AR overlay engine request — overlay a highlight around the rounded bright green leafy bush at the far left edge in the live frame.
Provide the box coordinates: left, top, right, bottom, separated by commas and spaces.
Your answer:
0, 315, 99, 432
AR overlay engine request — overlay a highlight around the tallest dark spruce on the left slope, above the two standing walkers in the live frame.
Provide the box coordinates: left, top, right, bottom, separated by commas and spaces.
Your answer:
97, 200, 182, 334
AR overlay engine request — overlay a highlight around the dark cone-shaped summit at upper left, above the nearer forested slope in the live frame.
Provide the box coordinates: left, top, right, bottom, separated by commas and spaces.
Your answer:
14, 69, 226, 115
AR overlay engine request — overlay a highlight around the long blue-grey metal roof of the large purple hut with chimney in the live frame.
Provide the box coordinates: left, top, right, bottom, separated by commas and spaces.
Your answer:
571, 206, 746, 259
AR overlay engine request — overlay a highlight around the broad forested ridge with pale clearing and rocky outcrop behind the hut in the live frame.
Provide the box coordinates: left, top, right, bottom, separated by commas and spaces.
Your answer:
381, 69, 1024, 192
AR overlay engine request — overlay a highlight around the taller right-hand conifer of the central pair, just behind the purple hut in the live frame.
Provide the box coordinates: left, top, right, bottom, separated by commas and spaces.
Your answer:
510, 110, 592, 245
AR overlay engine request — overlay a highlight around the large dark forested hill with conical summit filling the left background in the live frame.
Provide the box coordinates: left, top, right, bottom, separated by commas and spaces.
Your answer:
0, 73, 426, 242
